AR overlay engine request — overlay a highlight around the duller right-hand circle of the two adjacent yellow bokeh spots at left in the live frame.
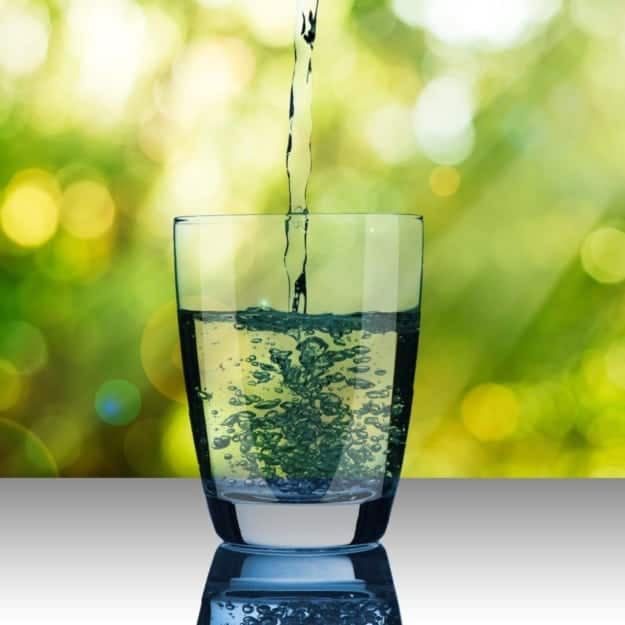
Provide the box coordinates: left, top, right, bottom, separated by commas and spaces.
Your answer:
61, 180, 115, 239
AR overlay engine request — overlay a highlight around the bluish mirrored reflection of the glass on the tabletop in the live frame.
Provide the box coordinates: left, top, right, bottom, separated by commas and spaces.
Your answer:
198, 544, 401, 625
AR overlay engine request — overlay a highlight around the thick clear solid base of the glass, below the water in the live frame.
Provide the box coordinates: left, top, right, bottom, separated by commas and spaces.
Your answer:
207, 496, 393, 550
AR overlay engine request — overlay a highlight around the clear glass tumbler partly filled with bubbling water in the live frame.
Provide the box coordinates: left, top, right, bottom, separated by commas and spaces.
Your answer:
174, 214, 423, 549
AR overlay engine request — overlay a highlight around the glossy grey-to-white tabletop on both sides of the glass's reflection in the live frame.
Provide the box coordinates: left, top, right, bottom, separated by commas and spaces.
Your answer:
0, 480, 625, 625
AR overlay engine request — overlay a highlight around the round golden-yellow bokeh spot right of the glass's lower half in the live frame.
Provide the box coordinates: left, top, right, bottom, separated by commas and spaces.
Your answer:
462, 384, 520, 441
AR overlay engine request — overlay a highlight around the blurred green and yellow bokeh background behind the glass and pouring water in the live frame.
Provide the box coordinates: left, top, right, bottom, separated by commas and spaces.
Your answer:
0, 0, 625, 477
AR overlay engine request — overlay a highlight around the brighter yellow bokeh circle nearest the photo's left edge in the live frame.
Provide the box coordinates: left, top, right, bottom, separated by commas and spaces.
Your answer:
1, 170, 59, 247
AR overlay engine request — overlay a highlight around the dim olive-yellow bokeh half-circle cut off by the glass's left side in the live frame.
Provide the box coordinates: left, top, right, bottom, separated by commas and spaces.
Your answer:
141, 302, 186, 403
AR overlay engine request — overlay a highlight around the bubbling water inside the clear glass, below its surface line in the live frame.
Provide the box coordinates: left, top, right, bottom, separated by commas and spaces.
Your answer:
182, 309, 418, 501
